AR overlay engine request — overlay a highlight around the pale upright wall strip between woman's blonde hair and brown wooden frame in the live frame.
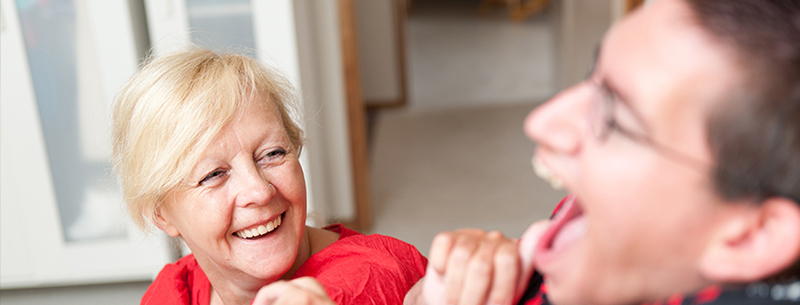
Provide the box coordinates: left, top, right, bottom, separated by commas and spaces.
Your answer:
294, 0, 355, 221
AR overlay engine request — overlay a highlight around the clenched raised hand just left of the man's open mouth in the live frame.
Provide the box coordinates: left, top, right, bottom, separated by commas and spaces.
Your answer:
405, 220, 549, 304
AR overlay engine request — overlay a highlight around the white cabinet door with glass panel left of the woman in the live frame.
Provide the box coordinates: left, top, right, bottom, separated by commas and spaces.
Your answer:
0, 0, 171, 288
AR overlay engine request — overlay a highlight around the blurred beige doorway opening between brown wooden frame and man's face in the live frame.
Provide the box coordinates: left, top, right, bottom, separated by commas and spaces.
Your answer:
362, 0, 561, 254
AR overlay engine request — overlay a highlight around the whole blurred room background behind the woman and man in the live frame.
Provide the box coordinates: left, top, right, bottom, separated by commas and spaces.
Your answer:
0, 0, 642, 305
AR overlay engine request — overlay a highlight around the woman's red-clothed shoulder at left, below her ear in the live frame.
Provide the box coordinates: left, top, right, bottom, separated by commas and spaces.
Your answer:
141, 254, 211, 305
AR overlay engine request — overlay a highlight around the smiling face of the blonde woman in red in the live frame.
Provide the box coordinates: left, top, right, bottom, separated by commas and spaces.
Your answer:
158, 98, 306, 282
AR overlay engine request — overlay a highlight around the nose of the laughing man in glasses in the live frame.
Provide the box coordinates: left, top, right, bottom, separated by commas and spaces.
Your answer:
524, 82, 594, 154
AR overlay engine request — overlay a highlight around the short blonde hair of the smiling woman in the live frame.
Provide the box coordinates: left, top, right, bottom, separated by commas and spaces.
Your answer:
113, 48, 304, 230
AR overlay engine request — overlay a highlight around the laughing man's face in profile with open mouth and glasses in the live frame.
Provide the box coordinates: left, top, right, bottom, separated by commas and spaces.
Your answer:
525, 0, 741, 304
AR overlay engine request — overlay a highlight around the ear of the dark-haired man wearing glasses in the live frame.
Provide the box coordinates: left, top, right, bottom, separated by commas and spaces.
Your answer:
700, 197, 800, 283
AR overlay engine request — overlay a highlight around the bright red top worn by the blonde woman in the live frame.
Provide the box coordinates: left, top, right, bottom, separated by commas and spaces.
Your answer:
141, 224, 428, 305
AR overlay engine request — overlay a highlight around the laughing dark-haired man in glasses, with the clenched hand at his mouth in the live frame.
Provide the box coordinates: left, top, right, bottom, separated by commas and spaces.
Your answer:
406, 0, 800, 305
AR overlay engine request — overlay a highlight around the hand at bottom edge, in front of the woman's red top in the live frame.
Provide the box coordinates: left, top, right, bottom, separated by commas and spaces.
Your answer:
252, 277, 336, 305
